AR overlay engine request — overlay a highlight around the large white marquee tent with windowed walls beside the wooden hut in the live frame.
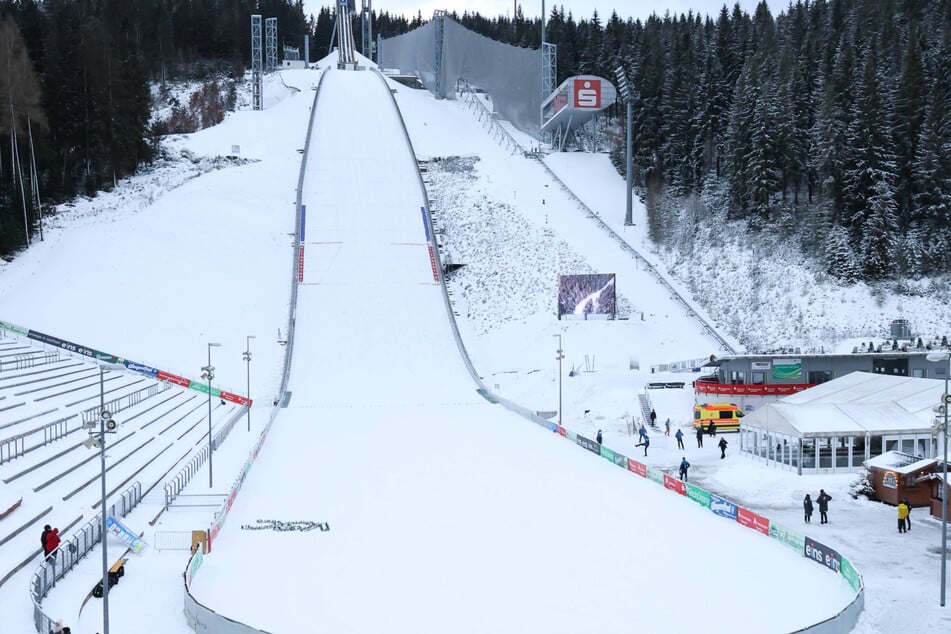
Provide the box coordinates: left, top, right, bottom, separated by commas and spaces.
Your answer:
740, 372, 944, 474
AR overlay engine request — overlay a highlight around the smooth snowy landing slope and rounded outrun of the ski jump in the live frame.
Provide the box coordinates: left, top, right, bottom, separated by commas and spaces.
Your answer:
191, 70, 850, 634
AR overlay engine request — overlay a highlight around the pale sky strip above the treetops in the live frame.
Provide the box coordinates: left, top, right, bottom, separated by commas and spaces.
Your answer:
304, 0, 772, 24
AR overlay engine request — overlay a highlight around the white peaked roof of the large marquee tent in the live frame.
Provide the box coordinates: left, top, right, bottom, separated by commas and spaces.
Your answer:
743, 372, 944, 438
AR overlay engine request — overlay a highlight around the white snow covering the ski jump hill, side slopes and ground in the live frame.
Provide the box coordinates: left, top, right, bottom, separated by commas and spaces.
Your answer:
0, 54, 951, 634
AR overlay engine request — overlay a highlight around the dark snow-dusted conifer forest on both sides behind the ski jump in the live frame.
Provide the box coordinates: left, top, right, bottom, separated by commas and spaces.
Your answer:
0, 0, 951, 281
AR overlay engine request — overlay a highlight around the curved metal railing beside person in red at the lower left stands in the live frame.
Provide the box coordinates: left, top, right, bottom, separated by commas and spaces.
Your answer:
30, 482, 142, 634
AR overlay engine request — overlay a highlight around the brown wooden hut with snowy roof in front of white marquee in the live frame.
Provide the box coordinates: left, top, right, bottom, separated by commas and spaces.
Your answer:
864, 451, 940, 508
